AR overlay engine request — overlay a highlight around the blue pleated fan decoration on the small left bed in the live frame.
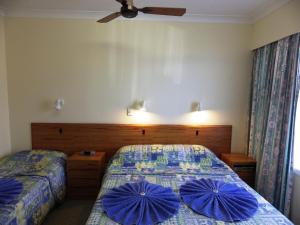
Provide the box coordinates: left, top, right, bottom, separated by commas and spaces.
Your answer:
0, 178, 23, 205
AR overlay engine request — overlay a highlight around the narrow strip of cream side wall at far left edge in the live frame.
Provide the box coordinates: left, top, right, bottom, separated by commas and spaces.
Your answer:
0, 15, 11, 157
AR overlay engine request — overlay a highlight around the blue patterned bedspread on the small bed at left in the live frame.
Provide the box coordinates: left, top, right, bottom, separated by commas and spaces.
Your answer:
0, 150, 66, 225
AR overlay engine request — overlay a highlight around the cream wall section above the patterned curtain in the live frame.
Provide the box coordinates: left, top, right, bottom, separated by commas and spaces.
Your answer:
252, 0, 300, 49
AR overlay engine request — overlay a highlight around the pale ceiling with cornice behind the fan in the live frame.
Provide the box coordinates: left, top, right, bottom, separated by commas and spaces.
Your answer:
0, 0, 289, 23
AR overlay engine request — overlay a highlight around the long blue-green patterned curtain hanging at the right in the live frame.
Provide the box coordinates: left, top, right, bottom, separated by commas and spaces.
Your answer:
249, 33, 300, 216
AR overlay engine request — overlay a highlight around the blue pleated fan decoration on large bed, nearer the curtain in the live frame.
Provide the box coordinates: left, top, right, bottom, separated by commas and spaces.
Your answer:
179, 179, 258, 222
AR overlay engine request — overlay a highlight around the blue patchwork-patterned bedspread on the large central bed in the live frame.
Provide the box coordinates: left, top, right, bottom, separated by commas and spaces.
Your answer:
87, 145, 292, 225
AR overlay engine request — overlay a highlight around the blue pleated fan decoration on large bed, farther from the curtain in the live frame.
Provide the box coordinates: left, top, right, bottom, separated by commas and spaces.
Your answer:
102, 181, 179, 225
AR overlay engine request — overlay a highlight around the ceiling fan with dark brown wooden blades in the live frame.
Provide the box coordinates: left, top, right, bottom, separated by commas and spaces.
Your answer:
97, 0, 186, 23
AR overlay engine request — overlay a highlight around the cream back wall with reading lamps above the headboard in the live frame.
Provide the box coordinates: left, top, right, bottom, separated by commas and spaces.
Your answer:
6, 18, 252, 152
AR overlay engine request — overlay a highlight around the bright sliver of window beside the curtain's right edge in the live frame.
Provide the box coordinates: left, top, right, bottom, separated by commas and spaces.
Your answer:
294, 89, 300, 174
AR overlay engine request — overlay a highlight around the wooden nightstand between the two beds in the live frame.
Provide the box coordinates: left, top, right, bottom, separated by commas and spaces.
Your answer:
67, 152, 105, 199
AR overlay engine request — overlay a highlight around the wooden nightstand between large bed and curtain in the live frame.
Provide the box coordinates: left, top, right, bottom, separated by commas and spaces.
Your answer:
221, 153, 256, 187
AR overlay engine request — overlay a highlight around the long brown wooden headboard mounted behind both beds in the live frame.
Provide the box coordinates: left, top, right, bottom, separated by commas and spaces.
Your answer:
31, 123, 232, 159
